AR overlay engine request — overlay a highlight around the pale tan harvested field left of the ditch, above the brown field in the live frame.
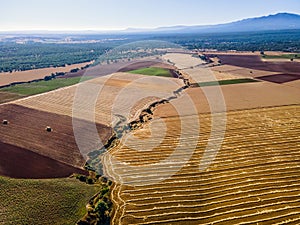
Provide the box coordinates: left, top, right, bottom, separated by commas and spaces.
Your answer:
15, 73, 182, 126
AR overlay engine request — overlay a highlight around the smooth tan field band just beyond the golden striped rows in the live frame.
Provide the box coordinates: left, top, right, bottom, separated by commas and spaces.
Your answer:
157, 82, 300, 117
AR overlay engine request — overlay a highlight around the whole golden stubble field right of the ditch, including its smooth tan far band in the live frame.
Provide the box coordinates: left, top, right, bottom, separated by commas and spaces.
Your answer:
102, 53, 300, 224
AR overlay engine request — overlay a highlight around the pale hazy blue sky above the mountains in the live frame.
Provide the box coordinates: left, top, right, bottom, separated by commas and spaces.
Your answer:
0, 0, 300, 30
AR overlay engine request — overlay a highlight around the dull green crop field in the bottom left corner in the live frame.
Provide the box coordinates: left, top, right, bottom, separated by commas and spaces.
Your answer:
0, 177, 99, 225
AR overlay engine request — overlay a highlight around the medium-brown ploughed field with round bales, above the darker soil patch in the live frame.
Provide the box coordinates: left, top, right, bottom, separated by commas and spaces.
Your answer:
0, 104, 112, 177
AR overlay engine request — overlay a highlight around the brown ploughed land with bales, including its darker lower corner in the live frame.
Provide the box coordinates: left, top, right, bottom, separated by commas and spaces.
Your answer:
0, 104, 112, 178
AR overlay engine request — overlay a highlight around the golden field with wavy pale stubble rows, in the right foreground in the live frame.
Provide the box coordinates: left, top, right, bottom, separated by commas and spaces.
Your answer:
103, 105, 300, 224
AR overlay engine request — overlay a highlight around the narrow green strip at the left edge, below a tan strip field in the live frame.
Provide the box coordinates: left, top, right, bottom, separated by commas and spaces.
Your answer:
0, 77, 92, 96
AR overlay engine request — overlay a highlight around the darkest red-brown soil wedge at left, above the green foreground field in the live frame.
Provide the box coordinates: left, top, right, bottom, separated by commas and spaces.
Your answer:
0, 142, 87, 179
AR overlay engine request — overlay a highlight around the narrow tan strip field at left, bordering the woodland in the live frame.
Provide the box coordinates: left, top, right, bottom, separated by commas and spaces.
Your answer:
0, 63, 89, 86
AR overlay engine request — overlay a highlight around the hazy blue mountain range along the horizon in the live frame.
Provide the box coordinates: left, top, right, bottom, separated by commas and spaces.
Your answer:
0, 13, 300, 34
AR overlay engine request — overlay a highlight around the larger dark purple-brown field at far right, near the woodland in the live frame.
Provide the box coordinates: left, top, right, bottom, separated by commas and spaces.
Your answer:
210, 54, 300, 74
